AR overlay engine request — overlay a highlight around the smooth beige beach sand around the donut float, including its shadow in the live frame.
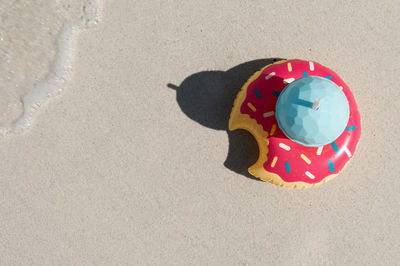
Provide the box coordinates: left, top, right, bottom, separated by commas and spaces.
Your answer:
0, 0, 400, 265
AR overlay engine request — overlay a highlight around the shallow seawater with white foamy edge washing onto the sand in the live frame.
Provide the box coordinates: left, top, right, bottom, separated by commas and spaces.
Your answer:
0, 0, 101, 134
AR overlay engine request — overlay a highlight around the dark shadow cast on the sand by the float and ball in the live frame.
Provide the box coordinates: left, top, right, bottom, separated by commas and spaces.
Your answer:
167, 58, 282, 180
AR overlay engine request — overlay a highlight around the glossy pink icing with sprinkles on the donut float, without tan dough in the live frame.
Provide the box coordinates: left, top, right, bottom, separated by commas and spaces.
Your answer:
240, 59, 361, 184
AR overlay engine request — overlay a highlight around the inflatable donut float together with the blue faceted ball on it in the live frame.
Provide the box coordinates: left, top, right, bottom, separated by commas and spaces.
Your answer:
229, 59, 361, 188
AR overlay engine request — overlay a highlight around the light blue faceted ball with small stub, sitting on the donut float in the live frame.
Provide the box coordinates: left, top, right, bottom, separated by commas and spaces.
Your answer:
275, 76, 350, 147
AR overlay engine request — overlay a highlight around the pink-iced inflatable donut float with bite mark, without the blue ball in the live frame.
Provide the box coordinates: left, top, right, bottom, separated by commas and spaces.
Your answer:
229, 59, 361, 188
